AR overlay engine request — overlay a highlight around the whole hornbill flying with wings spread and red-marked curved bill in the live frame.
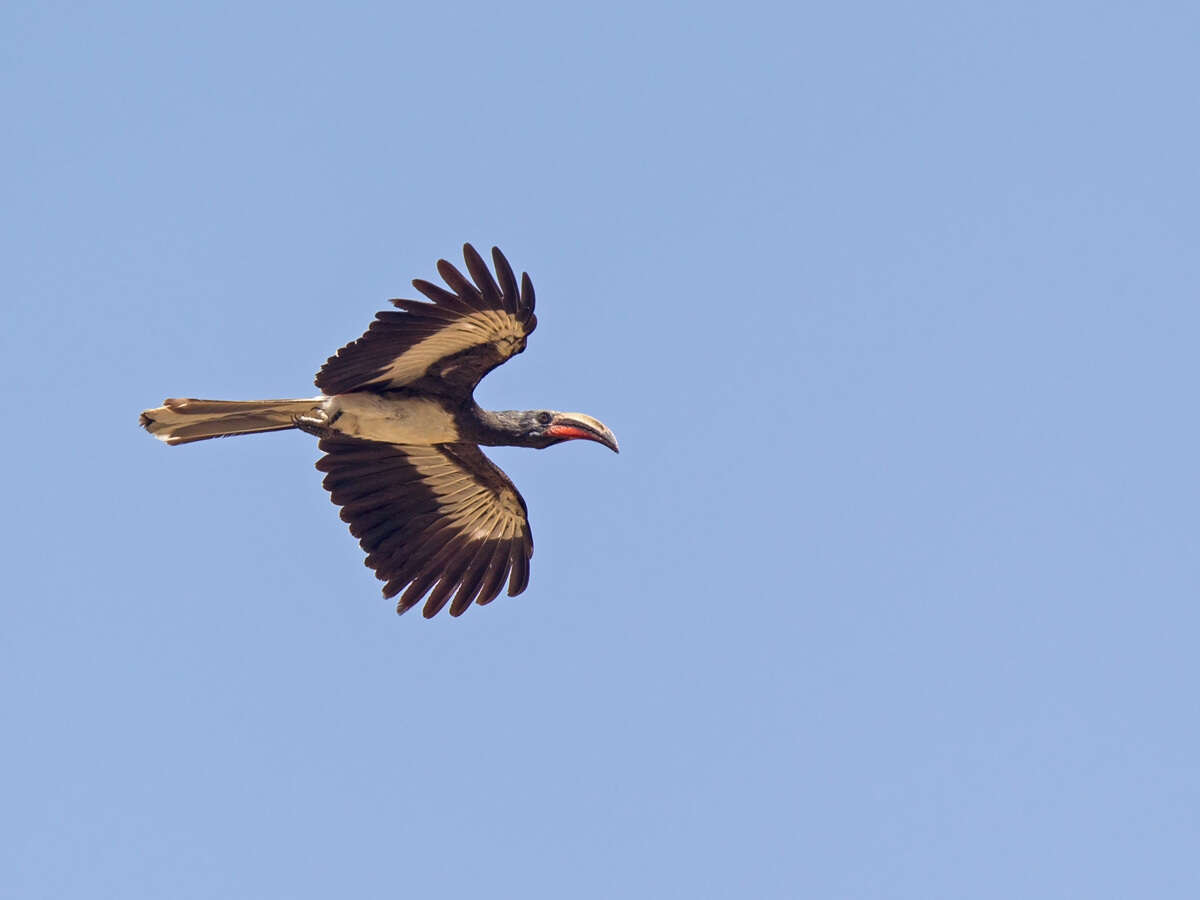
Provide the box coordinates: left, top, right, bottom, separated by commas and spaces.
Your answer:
139, 244, 617, 618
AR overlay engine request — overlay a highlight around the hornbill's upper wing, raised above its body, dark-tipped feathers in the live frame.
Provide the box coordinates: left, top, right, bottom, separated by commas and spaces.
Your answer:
317, 244, 538, 397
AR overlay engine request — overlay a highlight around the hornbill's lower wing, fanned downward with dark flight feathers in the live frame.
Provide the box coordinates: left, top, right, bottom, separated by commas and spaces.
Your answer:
317, 437, 533, 618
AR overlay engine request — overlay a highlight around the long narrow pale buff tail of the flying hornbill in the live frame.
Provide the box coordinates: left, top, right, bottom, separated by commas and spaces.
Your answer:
138, 397, 323, 445
